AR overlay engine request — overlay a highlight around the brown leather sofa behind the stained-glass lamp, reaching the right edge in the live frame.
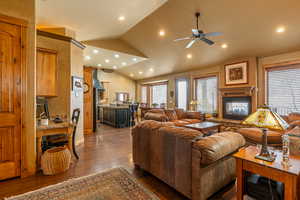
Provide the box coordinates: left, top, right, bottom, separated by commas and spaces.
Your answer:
238, 113, 300, 146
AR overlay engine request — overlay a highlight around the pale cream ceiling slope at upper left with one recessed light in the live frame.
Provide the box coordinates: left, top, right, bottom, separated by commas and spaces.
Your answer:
37, 0, 166, 41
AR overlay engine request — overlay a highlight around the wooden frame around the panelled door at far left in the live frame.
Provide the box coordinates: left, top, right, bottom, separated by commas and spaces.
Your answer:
0, 14, 29, 177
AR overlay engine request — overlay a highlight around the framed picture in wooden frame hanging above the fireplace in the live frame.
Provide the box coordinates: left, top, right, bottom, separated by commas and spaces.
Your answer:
225, 61, 248, 85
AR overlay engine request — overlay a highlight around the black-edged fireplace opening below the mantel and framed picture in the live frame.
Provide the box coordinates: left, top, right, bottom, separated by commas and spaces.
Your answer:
223, 96, 252, 120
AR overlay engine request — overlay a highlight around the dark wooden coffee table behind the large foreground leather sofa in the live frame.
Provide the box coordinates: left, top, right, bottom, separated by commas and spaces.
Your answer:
184, 122, 221, 136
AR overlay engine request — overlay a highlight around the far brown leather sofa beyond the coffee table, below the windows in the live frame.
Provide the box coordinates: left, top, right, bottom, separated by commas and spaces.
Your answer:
144, 109, 205, 126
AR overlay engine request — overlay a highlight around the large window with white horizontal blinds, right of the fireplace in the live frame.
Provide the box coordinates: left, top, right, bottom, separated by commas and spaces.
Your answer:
267, 65, 300, 115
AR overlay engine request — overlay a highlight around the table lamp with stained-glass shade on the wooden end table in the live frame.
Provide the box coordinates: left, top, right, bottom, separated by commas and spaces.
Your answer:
242, 105, 289, 162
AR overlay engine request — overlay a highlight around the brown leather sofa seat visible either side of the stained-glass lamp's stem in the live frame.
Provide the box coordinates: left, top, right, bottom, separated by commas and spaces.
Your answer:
238, 128, 282, 144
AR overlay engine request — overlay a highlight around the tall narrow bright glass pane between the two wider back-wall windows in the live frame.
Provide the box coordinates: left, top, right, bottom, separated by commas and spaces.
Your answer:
176, 79, 188, 110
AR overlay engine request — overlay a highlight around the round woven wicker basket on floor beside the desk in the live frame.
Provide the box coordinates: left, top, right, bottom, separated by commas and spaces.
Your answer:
41, 147, 71, 175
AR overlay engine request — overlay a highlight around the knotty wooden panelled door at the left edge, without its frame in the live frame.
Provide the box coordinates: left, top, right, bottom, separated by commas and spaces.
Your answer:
0, 22, 21, 180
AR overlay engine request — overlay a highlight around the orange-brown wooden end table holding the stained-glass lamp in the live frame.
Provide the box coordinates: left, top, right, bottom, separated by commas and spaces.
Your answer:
233, 146, 300, 200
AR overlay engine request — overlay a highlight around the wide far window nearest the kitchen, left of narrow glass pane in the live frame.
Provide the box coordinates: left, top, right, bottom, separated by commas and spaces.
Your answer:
151, 84, 168, 105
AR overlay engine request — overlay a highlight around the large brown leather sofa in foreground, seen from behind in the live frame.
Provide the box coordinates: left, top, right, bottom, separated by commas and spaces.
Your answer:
132, 120, 245, 200
